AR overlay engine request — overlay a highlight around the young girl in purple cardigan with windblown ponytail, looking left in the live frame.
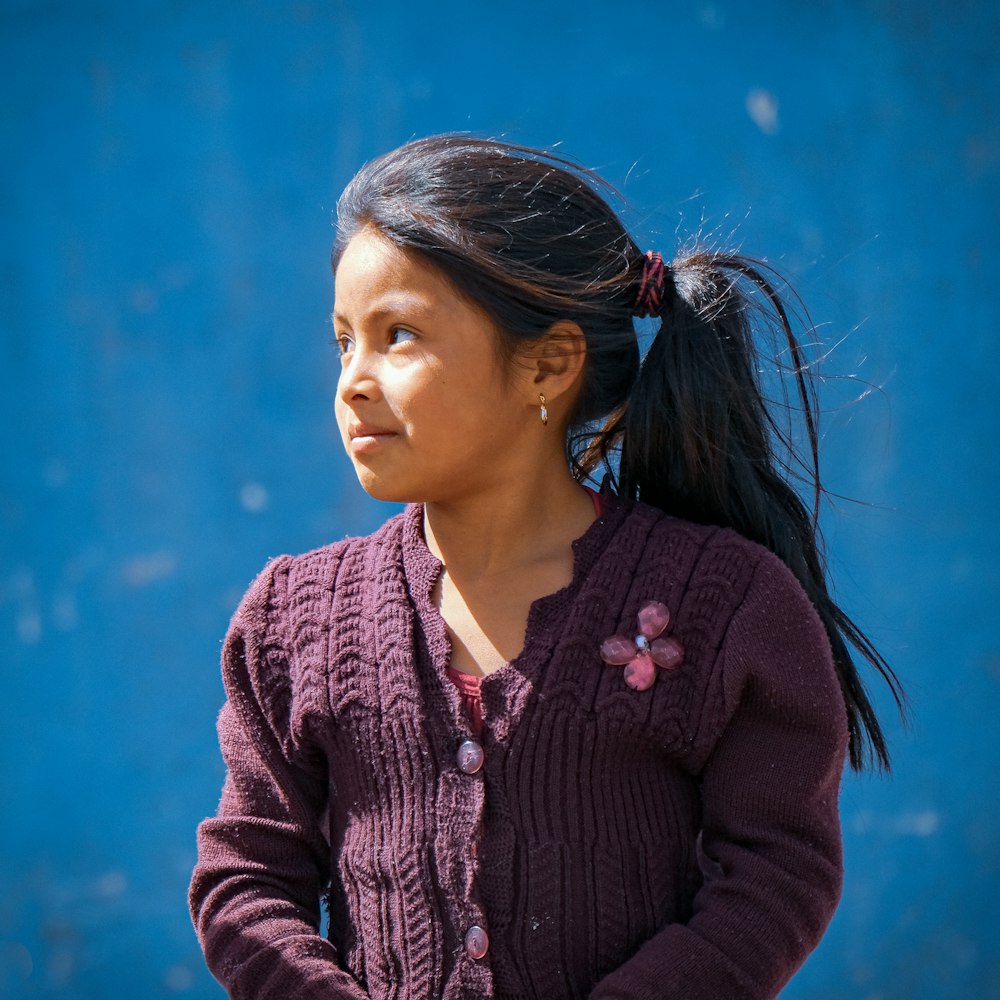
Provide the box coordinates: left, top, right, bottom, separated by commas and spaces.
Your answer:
190, 136, 901, 1000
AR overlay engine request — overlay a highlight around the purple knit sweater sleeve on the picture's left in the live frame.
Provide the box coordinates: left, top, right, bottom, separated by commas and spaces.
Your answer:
189, 557, 367, 1000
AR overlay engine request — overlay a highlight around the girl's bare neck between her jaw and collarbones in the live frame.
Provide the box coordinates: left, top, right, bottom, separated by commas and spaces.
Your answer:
424, 469, 594, 580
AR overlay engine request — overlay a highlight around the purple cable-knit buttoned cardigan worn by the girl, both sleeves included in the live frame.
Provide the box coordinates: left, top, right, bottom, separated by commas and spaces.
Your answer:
190, 493, 847, 1000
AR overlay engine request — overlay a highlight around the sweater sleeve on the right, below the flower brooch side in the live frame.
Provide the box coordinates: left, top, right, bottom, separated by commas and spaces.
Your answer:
590, 553, 848, 1000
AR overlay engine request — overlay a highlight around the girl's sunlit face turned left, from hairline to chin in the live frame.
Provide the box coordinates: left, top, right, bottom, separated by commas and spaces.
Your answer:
333, 229, 551, 502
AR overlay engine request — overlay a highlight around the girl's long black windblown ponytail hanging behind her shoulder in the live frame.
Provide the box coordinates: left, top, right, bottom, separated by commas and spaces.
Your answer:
580, 252, 905, 770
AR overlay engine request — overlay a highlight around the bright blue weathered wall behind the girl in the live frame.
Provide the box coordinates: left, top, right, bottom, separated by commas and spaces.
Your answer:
0, 0, 1000, 1000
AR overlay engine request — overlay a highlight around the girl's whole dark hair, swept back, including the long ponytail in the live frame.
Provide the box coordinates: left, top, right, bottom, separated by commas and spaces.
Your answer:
333, 135, 904, 770
